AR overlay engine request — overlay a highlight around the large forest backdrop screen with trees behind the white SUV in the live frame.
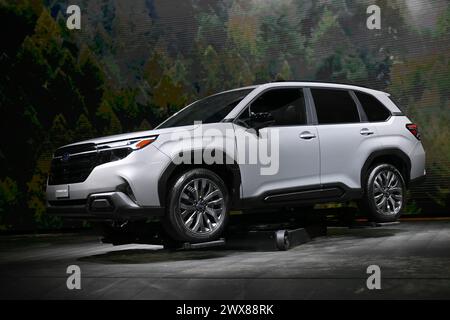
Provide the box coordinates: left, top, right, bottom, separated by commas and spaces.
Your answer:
0, 0, 450, 230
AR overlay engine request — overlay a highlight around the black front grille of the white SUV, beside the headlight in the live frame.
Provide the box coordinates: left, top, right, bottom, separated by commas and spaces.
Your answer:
48, 152, 99, 185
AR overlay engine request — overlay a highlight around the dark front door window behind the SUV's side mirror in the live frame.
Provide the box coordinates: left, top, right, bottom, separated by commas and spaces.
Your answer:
250, 88, 306, 126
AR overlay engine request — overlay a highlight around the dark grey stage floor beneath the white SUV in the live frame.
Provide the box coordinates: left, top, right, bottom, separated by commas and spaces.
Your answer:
0, 221, 450, 299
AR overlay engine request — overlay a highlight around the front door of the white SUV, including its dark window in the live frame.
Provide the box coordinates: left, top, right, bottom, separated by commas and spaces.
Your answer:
234, 87, 320, 199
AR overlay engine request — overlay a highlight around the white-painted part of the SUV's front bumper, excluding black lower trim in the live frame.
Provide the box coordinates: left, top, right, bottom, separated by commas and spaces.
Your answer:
46, 145, 170, 210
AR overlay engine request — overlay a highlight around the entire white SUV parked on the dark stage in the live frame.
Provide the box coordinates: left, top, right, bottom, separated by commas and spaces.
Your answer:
47, 82, 425, 242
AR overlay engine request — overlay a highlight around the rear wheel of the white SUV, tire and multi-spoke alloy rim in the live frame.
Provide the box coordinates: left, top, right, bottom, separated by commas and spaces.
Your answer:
359, 163, 406, 222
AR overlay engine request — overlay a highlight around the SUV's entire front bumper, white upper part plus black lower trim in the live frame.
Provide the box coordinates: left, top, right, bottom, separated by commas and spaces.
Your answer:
47, 145, 170, 221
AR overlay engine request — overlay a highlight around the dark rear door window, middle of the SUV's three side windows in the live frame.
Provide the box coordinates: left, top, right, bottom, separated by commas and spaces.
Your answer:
311, 88, 360, 124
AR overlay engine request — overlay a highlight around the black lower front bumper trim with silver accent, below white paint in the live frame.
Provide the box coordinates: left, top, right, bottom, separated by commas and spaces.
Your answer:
47, 191, 165, 221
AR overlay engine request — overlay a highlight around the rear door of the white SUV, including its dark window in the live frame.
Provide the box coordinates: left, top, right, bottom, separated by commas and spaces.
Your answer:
310, 88, 379, 188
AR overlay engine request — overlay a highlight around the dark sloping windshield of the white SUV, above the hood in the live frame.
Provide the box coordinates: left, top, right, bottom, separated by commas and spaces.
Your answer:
157, 88, 253, 129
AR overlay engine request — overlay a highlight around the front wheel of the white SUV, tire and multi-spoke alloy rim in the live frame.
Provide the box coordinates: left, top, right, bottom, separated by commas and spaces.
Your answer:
163, 168, 229, 243
